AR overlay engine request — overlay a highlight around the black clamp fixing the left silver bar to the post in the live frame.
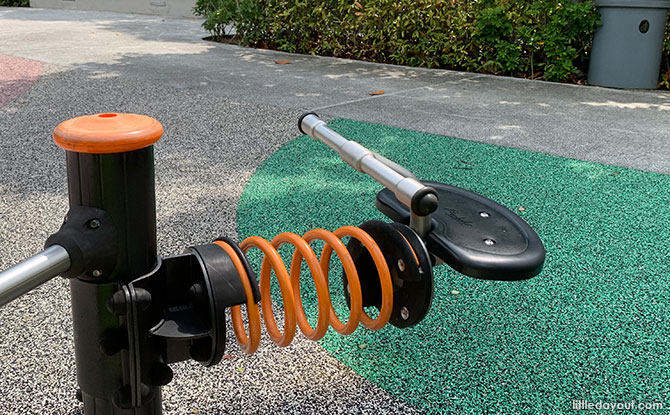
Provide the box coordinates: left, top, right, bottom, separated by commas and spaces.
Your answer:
44, 206, 118, 280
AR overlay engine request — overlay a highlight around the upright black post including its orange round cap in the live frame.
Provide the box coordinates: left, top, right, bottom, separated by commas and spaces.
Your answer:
54, 114, 162, 415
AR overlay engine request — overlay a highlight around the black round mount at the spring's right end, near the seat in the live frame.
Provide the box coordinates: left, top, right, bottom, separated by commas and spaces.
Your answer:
342, 220, 434, 328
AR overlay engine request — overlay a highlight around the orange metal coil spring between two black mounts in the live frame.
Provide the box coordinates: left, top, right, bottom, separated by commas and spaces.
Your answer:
214, 226, 393, 354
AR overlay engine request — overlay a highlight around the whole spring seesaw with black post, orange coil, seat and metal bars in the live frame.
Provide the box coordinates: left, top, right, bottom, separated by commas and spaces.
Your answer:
0, 114, 544, 415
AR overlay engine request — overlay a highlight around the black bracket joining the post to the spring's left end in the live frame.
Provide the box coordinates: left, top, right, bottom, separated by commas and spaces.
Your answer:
130, 238, 260, 366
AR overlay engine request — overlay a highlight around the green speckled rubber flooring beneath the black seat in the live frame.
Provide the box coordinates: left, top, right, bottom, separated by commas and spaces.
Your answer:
237, 119, 670, 414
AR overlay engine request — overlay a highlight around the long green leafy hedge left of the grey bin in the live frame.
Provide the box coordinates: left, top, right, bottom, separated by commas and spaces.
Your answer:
194, 0, 670, 83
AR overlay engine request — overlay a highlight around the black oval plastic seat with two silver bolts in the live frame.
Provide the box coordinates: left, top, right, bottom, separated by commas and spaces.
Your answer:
376, 181, 545, 281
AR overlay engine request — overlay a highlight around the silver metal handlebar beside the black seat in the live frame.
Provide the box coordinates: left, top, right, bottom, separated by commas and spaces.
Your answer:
300, 114, 427, 207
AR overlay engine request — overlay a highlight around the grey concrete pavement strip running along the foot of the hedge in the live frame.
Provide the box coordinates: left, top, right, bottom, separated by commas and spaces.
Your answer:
0, 9, 670, 172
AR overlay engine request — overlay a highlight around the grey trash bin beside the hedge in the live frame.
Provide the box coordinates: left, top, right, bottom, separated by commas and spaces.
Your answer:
588, 0, 670, 89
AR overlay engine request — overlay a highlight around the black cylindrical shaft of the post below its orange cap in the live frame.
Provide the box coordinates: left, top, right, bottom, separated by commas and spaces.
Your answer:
67, 147, 161, 415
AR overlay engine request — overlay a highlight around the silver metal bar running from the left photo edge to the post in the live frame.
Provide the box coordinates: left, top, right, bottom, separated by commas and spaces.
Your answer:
0, 245, 70, 307
